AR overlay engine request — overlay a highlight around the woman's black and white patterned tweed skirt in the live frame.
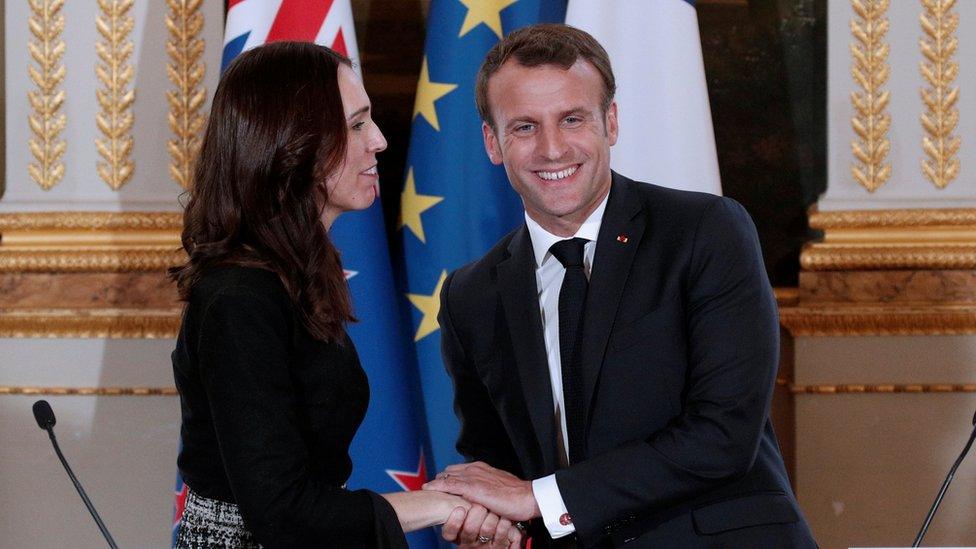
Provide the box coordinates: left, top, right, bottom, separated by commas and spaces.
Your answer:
176, 490, 261, 549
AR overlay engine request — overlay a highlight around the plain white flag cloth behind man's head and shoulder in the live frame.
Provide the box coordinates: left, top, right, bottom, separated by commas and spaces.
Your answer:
566, 0, 722, 194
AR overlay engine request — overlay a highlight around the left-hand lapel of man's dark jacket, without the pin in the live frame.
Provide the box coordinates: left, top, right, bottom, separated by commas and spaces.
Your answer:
497, 225, 556, 471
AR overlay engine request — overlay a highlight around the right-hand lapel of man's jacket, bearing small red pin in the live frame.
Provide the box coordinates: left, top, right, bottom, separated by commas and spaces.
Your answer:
582, 173, 646, 430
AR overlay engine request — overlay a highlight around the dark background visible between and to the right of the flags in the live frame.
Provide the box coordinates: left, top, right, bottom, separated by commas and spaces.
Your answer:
352, 0, 827, 286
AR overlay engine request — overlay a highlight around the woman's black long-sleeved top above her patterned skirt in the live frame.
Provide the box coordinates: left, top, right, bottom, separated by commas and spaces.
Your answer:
173, 266, 405, 547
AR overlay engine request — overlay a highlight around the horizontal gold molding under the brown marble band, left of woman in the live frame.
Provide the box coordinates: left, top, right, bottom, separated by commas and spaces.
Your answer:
0, 308, 182, 339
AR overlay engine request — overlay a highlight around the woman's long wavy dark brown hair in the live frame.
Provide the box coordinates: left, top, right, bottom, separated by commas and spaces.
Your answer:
170, 42, 355, 341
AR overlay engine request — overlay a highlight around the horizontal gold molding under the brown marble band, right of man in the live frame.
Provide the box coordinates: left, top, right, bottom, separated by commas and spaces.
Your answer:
779, 304, 976, 337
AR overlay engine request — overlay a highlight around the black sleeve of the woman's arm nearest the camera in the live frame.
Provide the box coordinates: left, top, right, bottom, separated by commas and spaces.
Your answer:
197, 288, 406, 547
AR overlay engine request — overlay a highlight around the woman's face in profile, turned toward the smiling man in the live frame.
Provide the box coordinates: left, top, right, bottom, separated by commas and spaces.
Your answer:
321, 65, 386, 229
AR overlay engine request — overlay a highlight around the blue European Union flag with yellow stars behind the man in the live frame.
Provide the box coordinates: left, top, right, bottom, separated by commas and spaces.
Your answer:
400, 0, 566, 469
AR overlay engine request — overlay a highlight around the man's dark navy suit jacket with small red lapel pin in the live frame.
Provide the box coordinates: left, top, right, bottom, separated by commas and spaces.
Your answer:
440, 173, 815, 547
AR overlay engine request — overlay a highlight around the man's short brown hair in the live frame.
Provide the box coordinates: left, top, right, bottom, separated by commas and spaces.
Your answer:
475, 23, 617, 130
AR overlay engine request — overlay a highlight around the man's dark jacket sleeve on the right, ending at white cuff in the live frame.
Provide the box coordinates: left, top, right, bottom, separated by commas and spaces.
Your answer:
556, 198, 779, 545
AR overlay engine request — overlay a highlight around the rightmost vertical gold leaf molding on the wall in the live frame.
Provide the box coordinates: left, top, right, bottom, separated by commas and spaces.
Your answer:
919, 0, 961, 189
